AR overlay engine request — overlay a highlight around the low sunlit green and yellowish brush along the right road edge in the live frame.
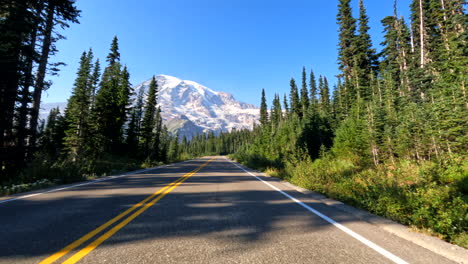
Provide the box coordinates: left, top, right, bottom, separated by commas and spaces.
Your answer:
232, 153, 468, 248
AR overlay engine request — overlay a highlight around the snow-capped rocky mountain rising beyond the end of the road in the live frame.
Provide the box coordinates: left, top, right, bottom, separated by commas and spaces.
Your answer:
134, 75, 259, 138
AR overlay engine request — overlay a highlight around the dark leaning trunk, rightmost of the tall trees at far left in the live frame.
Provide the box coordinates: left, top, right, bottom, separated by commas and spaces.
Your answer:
30, 1, 55, 155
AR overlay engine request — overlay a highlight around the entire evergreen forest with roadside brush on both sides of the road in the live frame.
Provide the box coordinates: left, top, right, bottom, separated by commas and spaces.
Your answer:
0, 0, 468, 247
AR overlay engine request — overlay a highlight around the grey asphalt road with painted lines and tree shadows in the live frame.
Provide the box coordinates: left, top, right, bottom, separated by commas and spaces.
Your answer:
0, 157, 460, 264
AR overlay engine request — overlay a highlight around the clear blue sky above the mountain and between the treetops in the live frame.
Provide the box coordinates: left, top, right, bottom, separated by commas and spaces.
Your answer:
43, 0, 410, 105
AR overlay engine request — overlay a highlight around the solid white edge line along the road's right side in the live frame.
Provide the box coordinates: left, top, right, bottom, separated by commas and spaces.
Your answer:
226, 158, 408, 264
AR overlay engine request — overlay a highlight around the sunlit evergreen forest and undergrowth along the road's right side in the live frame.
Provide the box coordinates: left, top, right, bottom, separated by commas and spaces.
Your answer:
187, 0, 468, 247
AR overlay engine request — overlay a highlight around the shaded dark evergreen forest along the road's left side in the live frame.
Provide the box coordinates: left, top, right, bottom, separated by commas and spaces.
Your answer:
0, 0, 190, 194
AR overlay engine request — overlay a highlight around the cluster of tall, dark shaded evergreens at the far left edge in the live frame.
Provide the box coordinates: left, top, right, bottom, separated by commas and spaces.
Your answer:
0, 0, 80, 179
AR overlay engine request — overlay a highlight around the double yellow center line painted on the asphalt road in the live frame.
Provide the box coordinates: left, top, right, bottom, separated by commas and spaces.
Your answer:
39, 158, 214, 264
